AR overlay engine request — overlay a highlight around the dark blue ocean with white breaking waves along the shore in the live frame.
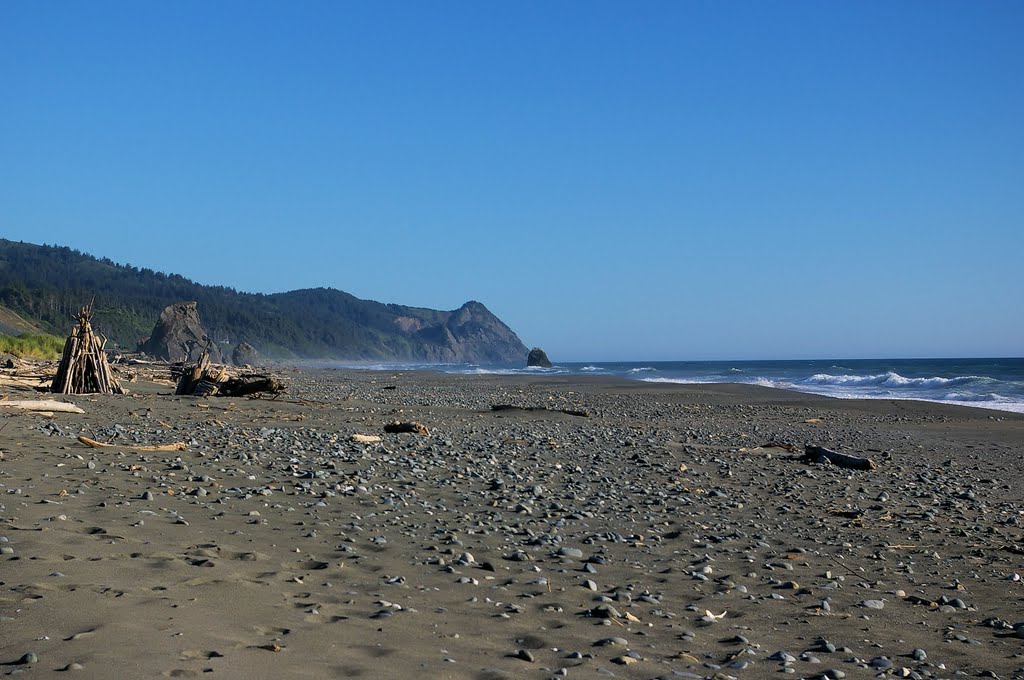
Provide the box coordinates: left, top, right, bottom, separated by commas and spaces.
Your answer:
329, 358, 1024, 413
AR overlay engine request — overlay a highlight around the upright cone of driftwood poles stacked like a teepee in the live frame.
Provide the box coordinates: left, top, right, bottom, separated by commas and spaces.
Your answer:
50, 304, 125, 394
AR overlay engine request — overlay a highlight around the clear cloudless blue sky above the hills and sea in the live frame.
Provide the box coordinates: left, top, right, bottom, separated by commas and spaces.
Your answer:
0, 0, 1024, 360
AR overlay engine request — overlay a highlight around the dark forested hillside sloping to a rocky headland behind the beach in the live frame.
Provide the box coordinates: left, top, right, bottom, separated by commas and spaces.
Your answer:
0, 240, 526, 363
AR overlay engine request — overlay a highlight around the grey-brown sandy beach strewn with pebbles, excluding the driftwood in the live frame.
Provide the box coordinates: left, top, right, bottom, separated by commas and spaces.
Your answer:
0, 371, 1024, 680
